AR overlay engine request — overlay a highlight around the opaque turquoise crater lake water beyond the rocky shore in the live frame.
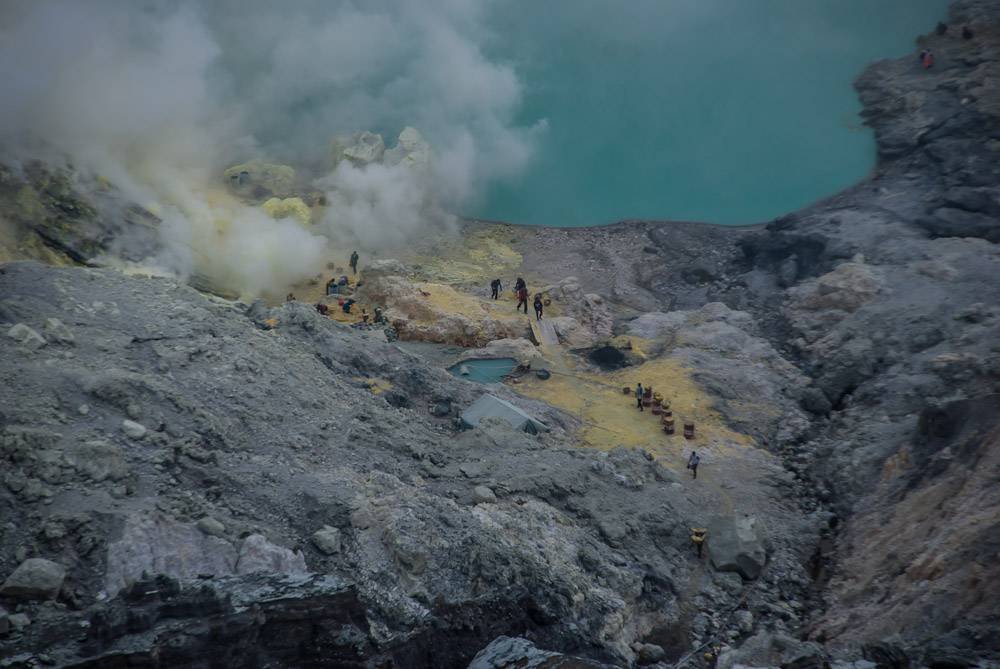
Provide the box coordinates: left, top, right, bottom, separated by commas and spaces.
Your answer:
474, 0, 947, 226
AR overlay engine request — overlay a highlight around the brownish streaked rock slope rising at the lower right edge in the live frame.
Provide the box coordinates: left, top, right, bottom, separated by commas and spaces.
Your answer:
820, 395, 1000, 659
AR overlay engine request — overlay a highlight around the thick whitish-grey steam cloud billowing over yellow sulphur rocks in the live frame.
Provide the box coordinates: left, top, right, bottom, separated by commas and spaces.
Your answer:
0, 0, 543, 294
